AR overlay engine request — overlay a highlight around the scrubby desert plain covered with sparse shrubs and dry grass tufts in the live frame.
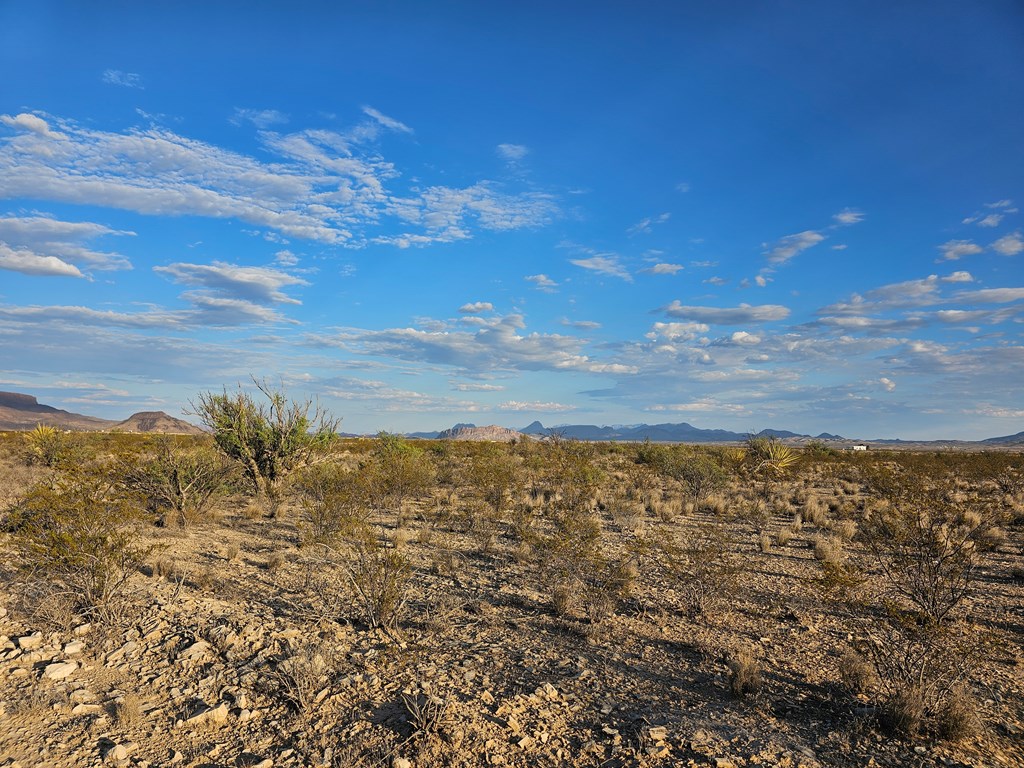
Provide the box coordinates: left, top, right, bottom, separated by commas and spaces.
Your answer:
0, 431, 1024, 768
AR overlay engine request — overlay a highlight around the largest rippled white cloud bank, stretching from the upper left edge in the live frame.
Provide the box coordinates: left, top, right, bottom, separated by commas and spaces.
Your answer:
0, 114, 559, 246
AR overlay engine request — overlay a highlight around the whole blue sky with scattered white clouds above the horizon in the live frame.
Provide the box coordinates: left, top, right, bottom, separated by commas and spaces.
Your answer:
0, 0, 1024, 438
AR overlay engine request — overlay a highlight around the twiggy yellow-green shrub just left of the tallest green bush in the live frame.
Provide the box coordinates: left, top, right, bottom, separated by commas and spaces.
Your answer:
123, 436, 231, 525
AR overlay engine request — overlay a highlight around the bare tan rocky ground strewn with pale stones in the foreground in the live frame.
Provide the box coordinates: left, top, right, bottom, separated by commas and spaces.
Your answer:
0, 448, 1024, 768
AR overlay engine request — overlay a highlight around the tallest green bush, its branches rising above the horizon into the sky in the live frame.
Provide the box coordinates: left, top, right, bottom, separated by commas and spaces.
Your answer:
191, 379, 339, 514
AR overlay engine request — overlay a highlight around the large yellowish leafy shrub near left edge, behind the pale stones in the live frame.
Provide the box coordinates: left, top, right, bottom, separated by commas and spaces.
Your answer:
7, 468, 152, 621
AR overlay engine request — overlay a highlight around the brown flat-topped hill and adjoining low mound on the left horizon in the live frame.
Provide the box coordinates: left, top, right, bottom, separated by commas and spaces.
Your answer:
0, 392, 202, 434
